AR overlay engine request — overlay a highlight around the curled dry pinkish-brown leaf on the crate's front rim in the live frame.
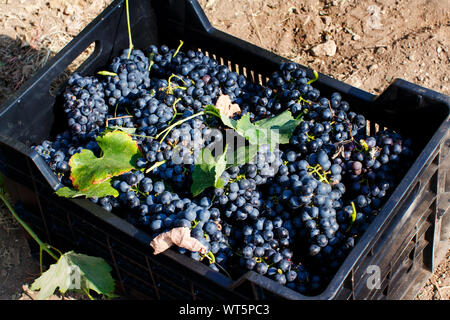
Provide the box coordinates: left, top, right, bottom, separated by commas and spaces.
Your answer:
150, 227, 206, 254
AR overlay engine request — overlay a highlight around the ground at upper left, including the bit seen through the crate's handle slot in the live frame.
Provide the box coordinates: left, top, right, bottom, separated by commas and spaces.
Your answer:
0, 0, 112, 104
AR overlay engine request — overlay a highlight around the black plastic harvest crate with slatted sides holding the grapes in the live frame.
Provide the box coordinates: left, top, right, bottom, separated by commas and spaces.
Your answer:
0, 0, 450, 300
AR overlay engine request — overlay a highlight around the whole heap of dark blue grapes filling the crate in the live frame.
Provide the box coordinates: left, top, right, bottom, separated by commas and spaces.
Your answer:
33, 45, 413, 295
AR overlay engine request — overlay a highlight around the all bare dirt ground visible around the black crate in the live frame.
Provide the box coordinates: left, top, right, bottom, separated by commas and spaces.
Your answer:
0, 0, 450, 300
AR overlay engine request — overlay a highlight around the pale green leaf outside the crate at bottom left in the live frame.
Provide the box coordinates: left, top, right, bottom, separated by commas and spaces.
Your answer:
31, 251, 116, 300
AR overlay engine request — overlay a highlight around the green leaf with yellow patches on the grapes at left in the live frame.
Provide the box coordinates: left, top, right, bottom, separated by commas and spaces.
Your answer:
69, 130, 142, 191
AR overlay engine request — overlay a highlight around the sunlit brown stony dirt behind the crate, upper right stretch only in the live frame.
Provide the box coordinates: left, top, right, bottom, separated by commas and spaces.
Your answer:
200, 0, 450, 94
